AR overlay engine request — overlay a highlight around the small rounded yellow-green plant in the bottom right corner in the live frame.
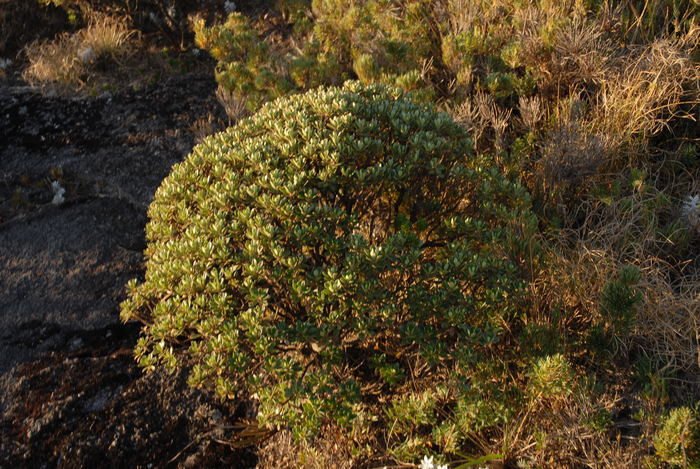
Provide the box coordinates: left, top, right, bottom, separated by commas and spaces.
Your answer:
654, 407, 700, 468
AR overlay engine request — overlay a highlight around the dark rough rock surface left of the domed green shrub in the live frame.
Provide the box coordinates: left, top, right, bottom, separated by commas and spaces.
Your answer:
0, 64, 256, 468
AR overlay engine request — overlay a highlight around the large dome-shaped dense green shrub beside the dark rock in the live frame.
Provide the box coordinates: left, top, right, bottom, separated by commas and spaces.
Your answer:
122, 82, 532, 446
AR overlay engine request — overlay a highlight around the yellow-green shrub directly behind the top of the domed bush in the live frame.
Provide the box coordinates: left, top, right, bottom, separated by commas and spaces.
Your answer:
194, 0, 439, 110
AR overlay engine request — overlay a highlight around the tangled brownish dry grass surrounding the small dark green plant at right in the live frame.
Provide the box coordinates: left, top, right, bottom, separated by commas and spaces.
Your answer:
532, 175, 700, 372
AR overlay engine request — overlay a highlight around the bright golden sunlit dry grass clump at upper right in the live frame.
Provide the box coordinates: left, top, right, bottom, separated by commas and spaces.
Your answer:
520, 27, 700, 210
